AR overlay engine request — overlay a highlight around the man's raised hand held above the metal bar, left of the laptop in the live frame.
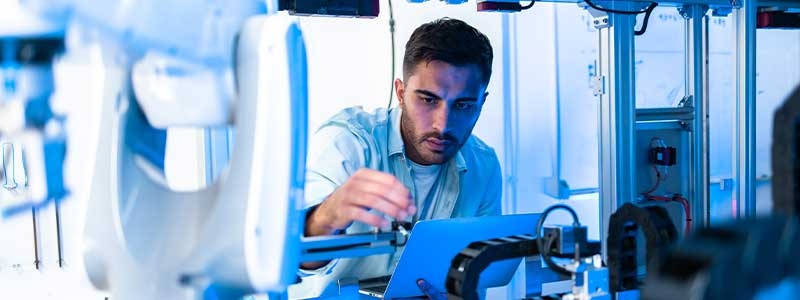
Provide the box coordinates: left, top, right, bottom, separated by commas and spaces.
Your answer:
305, 169, 417, 236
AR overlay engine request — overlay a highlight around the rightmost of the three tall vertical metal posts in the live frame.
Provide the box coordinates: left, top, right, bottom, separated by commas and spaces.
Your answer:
733, 0, 757, 218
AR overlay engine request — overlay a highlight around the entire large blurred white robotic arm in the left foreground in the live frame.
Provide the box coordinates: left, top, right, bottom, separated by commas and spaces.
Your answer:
0, 0, 307, 299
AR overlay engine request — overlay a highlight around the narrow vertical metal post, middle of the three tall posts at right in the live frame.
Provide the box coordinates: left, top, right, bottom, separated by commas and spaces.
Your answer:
681, 5, 710, 229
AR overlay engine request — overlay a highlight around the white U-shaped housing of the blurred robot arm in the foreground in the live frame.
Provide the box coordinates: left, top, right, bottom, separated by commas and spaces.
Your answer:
84, 15, 307, 299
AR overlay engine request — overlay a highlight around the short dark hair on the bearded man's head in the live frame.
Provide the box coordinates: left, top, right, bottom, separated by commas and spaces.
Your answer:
403, 18, 493, 84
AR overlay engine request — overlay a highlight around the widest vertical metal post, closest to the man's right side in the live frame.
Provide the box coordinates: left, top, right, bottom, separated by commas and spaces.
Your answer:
598, 2, 636, 256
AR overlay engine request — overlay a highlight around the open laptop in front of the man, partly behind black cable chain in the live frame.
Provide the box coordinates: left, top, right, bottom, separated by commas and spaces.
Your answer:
359, 214, 540, 299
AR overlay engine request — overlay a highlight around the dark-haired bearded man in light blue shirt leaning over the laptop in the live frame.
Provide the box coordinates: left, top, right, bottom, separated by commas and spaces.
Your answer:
290, 18, 502, 295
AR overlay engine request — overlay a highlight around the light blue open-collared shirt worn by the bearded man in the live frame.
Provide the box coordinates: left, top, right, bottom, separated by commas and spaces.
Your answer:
289, 107, 502, 298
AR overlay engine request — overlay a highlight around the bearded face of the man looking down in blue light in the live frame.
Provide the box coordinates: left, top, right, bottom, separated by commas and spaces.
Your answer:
395, 60, 487, 165
